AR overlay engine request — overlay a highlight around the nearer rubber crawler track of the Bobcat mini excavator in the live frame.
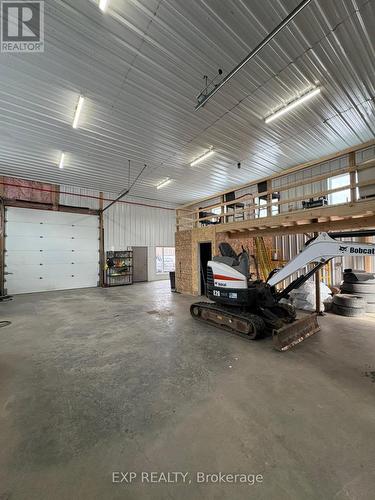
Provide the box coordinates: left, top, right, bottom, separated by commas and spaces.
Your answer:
190, 302, 266, 340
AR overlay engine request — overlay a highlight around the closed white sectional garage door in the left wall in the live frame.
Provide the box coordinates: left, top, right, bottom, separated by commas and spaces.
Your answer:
5, 208, 99, 294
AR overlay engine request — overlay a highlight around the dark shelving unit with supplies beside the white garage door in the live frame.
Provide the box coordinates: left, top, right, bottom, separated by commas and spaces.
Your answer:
105, 250, 133, 287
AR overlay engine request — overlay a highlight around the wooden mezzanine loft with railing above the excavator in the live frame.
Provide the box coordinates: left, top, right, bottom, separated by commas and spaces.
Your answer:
176, 140, 375, 238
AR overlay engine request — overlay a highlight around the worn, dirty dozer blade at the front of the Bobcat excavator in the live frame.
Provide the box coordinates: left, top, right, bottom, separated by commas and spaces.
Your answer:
272, 314, 320, 351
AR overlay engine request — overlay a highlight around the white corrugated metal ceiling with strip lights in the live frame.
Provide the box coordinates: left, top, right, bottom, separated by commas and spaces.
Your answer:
0, 0, 375, 203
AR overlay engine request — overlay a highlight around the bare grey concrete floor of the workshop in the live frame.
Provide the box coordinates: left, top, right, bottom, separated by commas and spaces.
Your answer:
0, 282, 375, 500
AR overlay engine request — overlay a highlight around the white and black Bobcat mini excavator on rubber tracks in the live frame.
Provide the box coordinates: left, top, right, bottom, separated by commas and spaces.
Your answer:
190, 231, 375, 351
